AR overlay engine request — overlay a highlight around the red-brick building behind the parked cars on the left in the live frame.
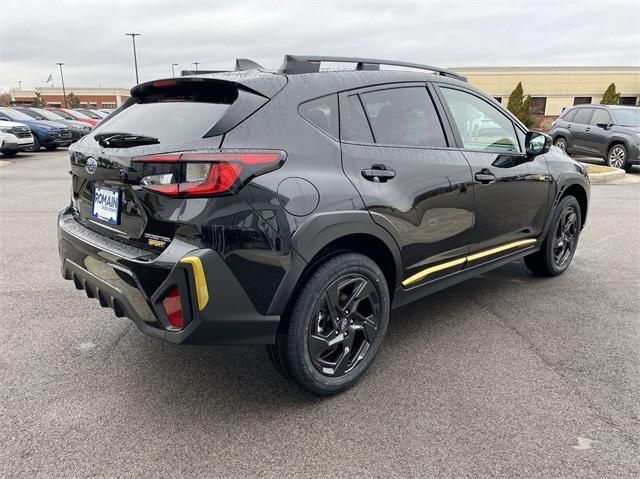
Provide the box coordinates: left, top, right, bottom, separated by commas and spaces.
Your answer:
9, 87, 130, 108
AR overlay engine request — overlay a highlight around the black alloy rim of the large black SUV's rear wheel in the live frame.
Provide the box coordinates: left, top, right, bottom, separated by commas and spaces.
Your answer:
307, 274, 380, 377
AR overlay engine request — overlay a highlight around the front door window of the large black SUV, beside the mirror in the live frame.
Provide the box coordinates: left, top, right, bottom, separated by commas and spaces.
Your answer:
441, 88, 522, 152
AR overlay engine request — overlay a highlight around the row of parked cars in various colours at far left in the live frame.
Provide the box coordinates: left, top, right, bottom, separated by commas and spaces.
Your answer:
0, 106, 113, 157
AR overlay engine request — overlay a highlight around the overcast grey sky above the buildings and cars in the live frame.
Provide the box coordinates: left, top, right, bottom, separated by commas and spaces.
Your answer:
0, 0, 640, 90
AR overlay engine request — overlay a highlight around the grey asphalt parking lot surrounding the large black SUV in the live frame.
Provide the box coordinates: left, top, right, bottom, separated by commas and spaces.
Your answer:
0, 150, 640, 478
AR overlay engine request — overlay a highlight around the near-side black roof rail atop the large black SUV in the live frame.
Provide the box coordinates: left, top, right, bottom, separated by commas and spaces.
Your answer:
278, 55, 467, 82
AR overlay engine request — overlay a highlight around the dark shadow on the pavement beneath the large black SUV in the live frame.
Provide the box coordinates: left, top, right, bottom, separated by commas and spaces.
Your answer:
108, 262, 531, 414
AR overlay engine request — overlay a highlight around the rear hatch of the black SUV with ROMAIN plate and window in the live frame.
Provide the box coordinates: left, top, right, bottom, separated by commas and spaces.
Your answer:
70, 74, 286, 252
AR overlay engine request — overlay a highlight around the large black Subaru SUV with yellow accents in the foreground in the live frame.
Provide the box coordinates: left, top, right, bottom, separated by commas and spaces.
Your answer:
58, 55, 589, 394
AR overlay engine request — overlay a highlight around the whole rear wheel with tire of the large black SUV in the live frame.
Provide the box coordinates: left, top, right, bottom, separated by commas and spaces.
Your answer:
271, 253, 390, 396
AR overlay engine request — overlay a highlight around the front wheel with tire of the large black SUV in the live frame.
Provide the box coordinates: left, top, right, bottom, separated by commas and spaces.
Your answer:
524, 196, 582, 276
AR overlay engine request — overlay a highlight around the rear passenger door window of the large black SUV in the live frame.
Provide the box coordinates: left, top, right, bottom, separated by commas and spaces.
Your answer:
361, 87, 447, 147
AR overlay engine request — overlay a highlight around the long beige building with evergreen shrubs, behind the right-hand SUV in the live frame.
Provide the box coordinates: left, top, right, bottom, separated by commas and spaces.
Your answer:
453, 67, 640, 126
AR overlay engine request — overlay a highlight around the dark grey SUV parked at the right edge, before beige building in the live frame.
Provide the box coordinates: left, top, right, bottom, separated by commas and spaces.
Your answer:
549, 105, 640, 171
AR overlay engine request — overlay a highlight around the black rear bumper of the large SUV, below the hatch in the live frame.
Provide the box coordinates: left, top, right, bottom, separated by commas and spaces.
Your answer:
58, 210, 280, 344
